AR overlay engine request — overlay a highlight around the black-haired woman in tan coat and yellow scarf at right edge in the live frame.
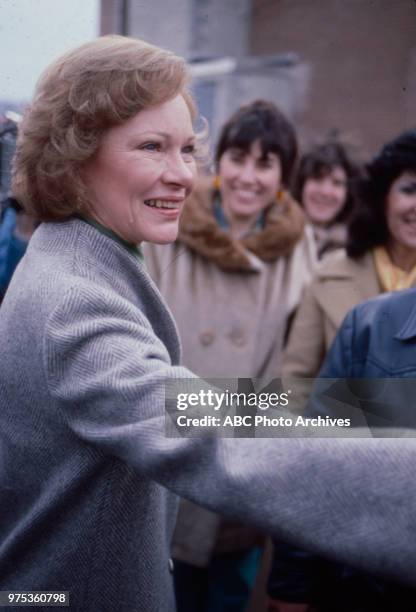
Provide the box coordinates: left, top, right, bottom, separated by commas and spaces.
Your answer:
283, 130, 416, 378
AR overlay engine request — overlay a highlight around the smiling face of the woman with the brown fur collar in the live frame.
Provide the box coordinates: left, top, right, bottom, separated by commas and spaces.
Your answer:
219, 140, 282, 223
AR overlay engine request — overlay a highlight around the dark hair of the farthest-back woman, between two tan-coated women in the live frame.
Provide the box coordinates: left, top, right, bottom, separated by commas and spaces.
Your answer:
293, 140, 361, 223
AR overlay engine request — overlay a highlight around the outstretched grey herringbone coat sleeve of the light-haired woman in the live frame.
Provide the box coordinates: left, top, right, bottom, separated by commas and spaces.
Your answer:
43, 286, 416, 582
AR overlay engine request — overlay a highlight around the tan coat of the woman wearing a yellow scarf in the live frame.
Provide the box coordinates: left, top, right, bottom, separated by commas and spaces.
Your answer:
282, 252, 381, 378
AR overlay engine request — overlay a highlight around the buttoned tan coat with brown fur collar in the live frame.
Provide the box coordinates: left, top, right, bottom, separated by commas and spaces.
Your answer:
143, 179, 316, 567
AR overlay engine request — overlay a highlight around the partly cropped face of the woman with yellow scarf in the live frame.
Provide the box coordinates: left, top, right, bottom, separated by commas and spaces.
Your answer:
386, 172, 416, 250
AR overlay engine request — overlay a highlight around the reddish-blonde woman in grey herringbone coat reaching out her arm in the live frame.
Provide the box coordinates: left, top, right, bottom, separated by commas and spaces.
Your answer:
0, 36, 416, 612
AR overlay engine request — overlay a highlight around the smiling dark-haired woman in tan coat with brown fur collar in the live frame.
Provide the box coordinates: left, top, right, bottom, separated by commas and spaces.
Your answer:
144, 101, 315, 612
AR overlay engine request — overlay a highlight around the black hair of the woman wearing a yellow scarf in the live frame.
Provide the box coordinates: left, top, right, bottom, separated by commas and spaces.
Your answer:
347, 129, 416, 257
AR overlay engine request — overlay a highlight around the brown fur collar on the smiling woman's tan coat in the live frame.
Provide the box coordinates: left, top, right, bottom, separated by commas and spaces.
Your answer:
178, 179, 305, 272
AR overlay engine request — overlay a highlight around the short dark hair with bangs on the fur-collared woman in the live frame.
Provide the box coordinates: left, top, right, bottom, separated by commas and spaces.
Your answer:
215, 100, 298, 186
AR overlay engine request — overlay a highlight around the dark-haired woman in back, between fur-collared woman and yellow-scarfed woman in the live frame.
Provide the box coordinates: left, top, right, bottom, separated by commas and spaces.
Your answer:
293, 140, 360, 259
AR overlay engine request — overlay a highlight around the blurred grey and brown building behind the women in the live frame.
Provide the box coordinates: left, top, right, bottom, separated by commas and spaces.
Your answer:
101, 0, 416, 154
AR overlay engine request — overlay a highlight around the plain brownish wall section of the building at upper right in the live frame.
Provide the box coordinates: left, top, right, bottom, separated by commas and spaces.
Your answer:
250, 0, 416, 153
